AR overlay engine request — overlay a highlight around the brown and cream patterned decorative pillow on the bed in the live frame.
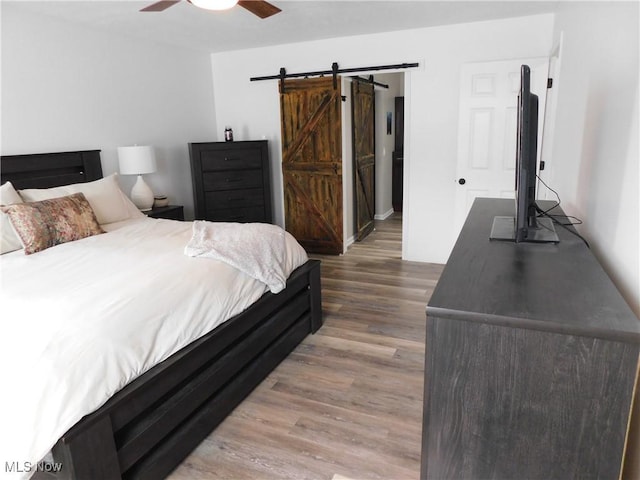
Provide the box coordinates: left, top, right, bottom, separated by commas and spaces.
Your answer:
2, 193, 104, 255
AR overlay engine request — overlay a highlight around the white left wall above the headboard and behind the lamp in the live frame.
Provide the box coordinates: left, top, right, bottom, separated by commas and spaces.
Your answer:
0, 3, 217, 216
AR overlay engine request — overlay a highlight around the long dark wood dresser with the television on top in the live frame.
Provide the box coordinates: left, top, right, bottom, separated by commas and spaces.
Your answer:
421, 199, 640, 480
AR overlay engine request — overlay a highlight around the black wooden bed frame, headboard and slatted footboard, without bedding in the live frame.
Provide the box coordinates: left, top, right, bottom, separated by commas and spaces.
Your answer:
0, 150, 322, 480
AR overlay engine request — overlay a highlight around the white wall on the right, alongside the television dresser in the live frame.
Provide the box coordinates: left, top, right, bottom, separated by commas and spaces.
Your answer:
550, 2, 640, 480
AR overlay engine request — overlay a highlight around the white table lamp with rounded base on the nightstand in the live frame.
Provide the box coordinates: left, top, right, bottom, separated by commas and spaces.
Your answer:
118, 145, 156, 212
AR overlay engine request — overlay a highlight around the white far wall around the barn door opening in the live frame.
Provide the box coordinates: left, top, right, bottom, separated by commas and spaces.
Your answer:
212, 15, 553, 263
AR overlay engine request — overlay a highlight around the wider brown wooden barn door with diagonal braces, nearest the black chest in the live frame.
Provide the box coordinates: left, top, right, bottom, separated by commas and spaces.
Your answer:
280, 77, 343, 254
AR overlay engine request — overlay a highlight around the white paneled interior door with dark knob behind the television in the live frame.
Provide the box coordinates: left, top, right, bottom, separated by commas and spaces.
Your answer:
455, 58, 549, 236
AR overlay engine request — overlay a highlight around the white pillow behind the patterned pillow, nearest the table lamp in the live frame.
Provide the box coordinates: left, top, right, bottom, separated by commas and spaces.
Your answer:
19, 173, 137, 225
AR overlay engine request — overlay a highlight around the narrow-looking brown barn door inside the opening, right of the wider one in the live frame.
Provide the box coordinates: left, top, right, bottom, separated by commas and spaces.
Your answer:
351, 78, 376, 241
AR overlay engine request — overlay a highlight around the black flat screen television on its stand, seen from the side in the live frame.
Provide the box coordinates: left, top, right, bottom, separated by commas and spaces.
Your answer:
489, 65, 560, 243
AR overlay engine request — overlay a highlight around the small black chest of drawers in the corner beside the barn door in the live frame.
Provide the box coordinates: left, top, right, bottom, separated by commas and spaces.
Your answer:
189, 140, 273, 223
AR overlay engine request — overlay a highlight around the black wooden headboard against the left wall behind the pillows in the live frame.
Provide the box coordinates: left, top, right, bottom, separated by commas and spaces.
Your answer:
0, 150, 102, 190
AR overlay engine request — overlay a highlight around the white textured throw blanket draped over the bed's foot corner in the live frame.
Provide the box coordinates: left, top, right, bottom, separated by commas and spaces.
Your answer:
184, 220, 308, 293
